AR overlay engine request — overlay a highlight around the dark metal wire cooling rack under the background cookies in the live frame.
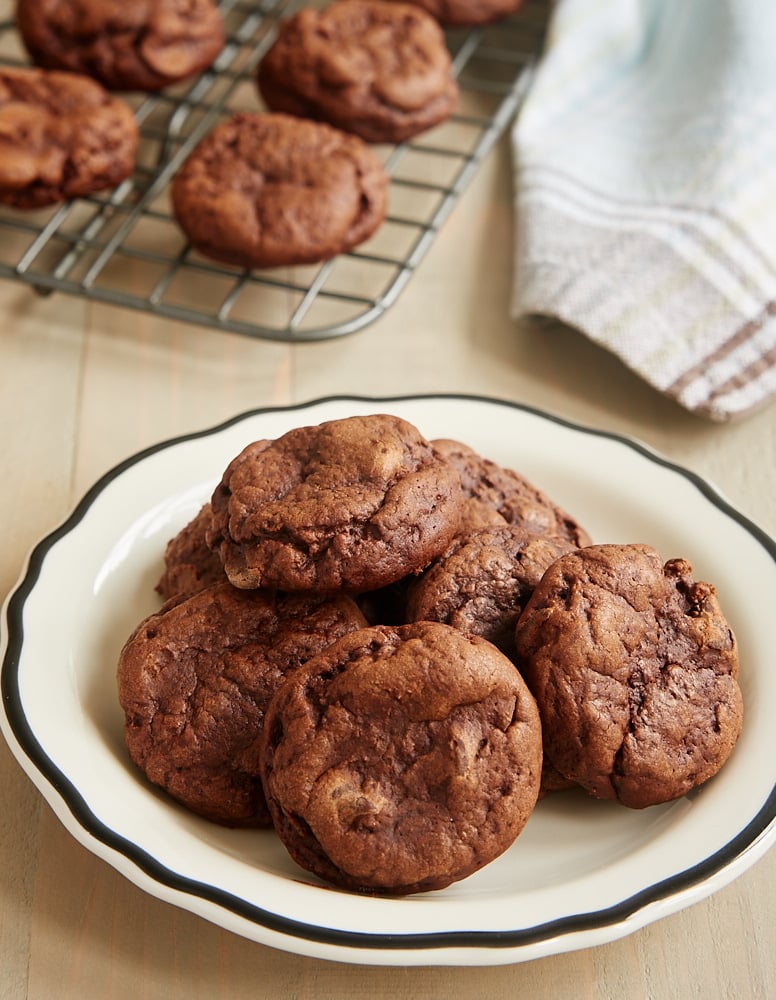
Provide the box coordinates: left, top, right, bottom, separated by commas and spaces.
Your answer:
0, 0, 547, 341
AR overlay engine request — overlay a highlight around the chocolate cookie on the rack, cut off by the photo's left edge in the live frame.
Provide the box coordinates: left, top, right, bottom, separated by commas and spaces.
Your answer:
0, 67, 138, 208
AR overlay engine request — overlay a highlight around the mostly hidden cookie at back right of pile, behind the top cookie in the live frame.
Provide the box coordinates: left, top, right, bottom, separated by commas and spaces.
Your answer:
432, 438, 590, 545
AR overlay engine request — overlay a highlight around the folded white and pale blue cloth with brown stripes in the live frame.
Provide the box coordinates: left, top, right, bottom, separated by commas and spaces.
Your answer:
512, 0, 776, 420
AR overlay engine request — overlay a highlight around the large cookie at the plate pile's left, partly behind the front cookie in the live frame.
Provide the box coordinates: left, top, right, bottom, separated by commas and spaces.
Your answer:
118, 583, 365, 826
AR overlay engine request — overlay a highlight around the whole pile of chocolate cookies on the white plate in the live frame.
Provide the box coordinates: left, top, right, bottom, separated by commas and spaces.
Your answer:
118, 414, 741, 895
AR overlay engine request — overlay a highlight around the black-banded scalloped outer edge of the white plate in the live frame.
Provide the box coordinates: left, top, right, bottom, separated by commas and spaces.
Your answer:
0, 392, 776, 961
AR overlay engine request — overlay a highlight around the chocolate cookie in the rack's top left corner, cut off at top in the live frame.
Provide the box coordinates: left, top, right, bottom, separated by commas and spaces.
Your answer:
16, 0, 224, 91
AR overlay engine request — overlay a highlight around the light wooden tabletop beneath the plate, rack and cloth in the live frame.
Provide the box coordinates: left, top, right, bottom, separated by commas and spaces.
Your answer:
0, 127, 776, 1000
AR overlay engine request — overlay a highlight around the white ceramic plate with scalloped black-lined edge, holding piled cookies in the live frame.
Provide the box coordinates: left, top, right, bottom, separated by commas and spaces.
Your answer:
2, 396, 776, 965
